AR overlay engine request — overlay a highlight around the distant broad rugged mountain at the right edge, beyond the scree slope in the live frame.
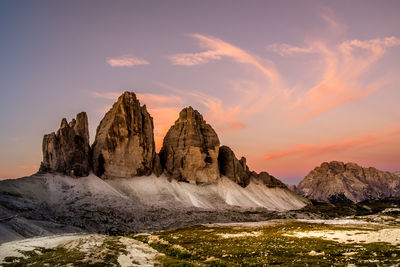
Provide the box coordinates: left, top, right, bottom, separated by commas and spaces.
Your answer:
298, 161, 400, 202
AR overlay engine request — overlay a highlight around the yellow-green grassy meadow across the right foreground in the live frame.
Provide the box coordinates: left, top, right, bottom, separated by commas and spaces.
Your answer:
135, 221, 400, 266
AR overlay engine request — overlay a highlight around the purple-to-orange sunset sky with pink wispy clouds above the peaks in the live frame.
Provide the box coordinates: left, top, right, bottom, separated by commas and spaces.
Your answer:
0, 0, 400, 183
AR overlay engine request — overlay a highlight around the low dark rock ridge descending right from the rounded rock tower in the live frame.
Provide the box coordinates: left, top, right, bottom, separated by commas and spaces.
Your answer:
218, 146, 286, 188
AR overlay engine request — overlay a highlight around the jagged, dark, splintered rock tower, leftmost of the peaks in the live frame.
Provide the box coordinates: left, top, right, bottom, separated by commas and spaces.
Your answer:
40, 112, 90, 177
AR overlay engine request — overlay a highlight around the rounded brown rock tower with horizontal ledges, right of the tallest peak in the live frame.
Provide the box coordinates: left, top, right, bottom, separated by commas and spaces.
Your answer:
160, 107, 220, 183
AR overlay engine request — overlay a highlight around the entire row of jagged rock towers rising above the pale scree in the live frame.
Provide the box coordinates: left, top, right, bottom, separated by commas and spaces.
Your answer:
41, 92, 294, 194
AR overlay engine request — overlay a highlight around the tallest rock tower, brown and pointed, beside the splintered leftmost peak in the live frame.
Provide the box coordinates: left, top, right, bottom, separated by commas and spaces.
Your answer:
92, 92, 155, 178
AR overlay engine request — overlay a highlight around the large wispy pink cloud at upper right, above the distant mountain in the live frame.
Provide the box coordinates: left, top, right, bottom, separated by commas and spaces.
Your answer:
269, 37, 400, 122
